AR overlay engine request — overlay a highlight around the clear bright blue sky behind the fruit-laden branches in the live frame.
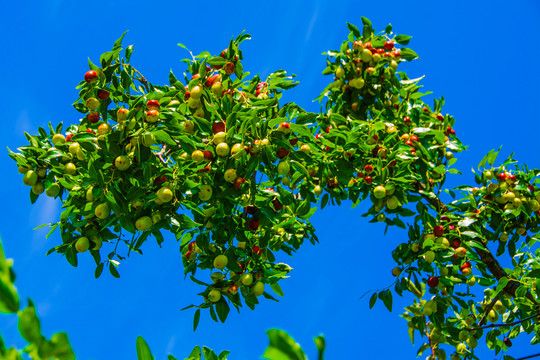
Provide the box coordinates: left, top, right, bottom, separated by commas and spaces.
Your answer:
0, 0, 540, 360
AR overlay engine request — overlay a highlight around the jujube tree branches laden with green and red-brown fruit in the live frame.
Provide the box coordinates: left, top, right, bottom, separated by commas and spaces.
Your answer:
5, 18, 540, 359
